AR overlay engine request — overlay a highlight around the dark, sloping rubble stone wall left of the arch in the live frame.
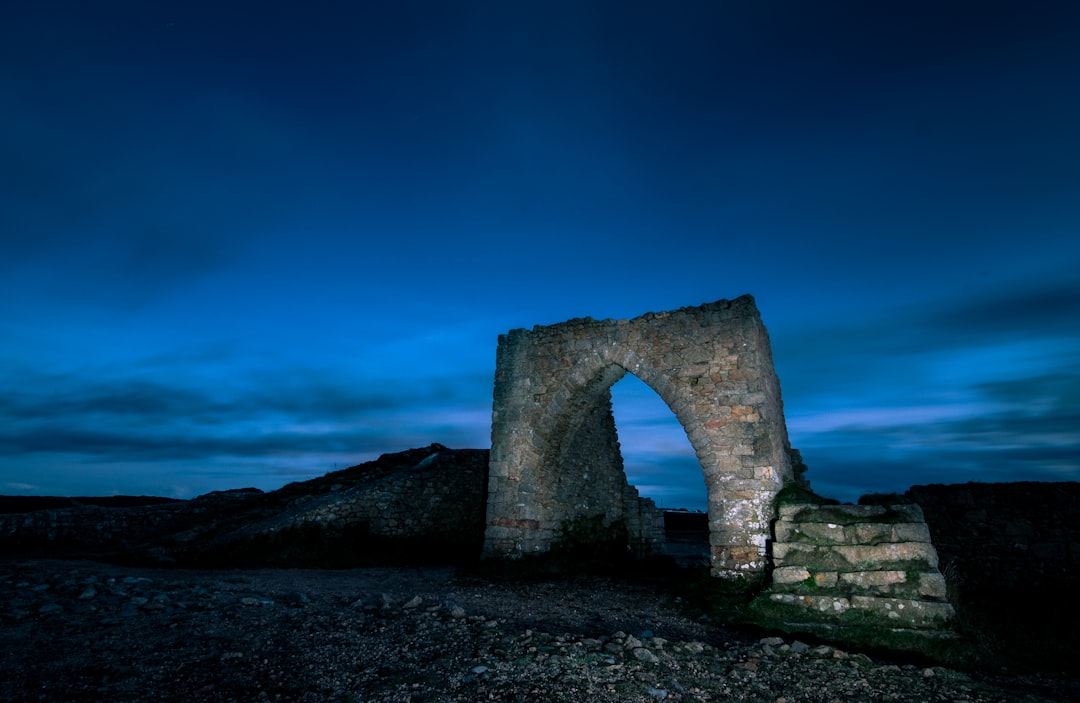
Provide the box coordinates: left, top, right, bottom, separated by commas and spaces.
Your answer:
0, 444, 488, 566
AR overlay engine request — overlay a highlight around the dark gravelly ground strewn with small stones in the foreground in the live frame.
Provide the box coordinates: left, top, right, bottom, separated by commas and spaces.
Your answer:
0, 559, 1080, 703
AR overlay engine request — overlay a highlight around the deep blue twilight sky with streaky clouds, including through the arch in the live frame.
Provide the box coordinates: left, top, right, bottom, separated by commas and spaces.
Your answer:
0, 0, 1080, 508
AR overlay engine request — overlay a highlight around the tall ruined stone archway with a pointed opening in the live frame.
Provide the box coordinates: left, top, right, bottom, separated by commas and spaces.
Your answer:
484, 296, 792, 577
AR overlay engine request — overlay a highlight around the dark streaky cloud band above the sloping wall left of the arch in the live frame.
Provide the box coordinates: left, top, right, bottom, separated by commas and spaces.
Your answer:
0, 360, 489, 470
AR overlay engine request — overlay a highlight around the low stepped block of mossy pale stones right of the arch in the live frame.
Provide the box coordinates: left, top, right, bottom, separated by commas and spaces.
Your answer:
764, 504, 955, 631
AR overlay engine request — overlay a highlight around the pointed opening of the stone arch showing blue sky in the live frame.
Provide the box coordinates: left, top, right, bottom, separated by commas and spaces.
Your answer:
611, 373, 710, 567
